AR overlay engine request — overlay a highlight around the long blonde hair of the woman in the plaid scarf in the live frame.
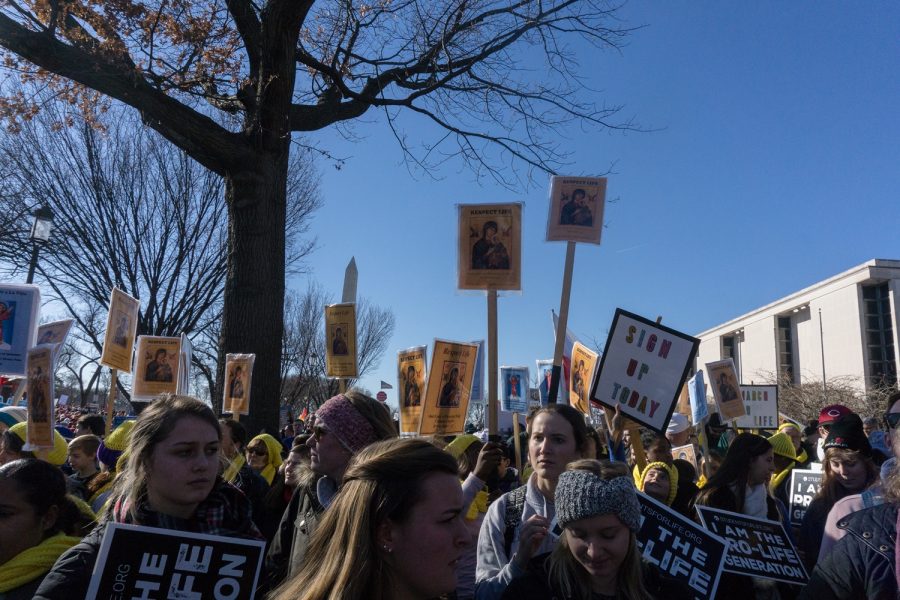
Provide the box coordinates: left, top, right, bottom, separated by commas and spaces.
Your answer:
104, 394, 222, 519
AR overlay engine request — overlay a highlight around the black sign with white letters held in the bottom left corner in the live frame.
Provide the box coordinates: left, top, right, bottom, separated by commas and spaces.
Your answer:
87, 521, 266, 600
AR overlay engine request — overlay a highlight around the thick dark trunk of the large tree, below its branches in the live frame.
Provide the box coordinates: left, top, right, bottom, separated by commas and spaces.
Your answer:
213, 147, 289, 434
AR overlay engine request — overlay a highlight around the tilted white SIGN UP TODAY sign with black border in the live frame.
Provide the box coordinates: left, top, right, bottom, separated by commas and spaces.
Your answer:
590, 308, 700, 434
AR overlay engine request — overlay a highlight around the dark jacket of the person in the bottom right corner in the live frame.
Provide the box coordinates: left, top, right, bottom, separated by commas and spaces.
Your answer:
800, 503, 897, 600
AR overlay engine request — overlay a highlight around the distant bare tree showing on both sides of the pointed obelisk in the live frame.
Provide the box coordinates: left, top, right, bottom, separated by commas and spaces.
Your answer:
281, 283, 395, 418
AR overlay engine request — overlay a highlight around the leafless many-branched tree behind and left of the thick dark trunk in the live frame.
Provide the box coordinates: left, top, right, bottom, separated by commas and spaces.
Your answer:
0, 104, 320, 404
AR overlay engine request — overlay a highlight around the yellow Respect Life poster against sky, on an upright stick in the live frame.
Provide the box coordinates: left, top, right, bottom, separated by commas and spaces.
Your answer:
458, 203, 522, 290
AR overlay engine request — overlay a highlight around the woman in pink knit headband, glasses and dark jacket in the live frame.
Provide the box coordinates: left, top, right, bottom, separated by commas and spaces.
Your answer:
266, 390, 397, 586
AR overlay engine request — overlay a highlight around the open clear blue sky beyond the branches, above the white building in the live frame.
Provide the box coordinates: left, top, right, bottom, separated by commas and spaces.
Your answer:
289, 2, 900, 404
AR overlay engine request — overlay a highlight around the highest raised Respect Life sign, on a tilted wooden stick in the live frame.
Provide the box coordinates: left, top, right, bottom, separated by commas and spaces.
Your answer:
547, 176, 606, 244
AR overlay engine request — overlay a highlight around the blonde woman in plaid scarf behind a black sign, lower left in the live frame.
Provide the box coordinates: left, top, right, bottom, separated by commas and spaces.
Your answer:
35, 395, 262, 600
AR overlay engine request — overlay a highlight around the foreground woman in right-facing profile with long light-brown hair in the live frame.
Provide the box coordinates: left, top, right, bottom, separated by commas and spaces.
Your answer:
273, 439, 472, 600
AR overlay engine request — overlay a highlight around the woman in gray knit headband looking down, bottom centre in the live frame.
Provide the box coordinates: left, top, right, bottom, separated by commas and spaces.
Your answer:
503, 460, 693, 600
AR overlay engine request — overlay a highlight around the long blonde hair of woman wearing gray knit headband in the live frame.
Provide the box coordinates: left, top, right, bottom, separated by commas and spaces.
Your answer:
547, 459, 653, 600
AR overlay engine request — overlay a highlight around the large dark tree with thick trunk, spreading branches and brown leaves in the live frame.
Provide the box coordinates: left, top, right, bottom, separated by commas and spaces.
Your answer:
0, 0, 630, 428
